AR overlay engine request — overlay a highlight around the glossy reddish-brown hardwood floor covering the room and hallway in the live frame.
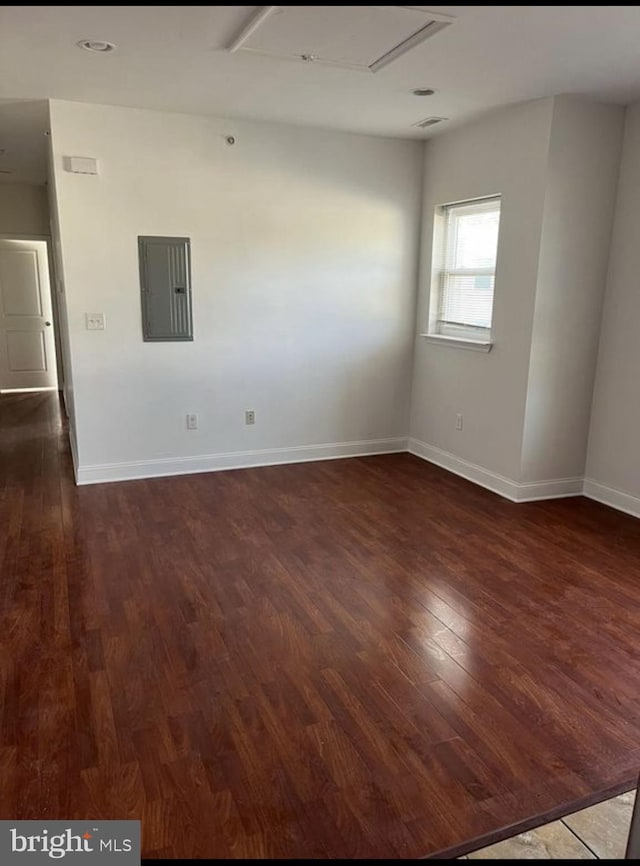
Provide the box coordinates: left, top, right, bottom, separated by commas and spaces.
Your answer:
0, 395, 640, 858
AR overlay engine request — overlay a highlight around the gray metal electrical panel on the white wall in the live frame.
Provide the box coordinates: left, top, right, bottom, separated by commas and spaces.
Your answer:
138, 237, 193, 342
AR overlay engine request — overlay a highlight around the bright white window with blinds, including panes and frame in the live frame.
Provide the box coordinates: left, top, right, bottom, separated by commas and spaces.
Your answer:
429, 196, 500, 343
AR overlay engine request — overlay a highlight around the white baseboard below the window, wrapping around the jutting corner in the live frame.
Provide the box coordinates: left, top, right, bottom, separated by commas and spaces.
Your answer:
409, 439, 582, 502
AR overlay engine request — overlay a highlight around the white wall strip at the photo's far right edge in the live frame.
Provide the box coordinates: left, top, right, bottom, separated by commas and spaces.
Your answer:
585, 103, 640, 516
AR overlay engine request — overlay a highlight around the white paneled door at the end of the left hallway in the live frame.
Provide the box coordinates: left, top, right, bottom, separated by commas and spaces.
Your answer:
0, 240, 58, 390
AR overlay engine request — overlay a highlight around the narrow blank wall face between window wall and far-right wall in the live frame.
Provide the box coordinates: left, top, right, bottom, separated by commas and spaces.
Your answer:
519, 96, 624, 481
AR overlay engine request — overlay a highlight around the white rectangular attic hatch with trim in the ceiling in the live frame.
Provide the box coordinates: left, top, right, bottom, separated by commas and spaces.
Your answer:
227, 6, 454, 72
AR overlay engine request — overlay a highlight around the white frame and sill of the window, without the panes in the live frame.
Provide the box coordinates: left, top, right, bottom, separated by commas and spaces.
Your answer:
423, 193, 502, 351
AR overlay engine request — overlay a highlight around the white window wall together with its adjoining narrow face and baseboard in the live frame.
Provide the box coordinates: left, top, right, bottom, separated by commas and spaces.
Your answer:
411, 96, 624, 499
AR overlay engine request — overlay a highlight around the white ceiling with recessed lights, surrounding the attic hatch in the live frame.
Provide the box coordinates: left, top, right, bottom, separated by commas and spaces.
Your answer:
0, 6, 640, 181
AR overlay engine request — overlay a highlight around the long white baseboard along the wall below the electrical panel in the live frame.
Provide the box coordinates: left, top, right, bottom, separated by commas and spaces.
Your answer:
72, 437, 407, 484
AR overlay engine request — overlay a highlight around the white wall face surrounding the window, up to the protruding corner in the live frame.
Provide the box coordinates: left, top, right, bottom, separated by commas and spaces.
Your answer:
411, 99, 553, 479
